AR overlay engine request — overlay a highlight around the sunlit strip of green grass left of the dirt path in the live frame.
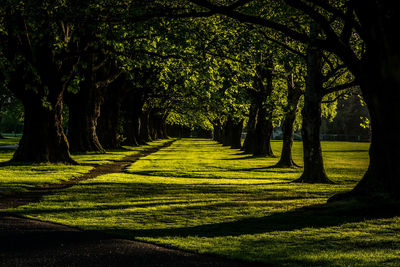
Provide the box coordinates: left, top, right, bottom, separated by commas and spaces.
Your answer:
0, 138, 170, 195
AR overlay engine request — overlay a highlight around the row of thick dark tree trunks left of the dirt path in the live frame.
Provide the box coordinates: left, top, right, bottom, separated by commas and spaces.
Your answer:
10, 56, 167, 164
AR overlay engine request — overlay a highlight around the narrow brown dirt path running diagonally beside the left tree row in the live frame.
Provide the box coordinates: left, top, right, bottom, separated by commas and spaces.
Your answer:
0, 139, 176, 210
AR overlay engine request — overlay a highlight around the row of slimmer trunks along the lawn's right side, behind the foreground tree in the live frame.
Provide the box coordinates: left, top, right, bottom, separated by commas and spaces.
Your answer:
214, 44, 340, 183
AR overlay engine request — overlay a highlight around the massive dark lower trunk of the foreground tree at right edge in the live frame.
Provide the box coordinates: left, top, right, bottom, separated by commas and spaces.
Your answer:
346, 81, 400, 199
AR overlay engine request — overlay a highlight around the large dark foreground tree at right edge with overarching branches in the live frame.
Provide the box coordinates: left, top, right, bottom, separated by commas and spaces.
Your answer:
187, 0, 400, 200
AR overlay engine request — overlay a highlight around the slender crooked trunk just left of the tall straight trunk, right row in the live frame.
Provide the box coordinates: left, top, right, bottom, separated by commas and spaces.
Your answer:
275, 74, 302, 168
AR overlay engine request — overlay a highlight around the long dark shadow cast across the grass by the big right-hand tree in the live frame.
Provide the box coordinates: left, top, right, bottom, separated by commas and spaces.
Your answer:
116, 204, 400, 237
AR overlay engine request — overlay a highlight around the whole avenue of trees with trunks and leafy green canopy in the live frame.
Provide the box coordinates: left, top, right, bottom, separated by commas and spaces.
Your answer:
0, 0, 400, 204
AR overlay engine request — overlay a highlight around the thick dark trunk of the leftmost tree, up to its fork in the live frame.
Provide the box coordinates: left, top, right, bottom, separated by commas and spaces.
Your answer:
8, 51, 76, 164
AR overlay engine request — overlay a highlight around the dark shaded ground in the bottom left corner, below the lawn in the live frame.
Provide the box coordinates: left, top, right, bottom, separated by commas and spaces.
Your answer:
0, 214, 265, 266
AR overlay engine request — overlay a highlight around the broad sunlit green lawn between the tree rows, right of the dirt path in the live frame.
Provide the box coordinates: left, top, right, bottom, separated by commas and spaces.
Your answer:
0, 139, 400, 266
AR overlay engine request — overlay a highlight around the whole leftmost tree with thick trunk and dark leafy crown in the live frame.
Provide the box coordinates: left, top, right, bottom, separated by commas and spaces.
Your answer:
0, 1, 88, 163
